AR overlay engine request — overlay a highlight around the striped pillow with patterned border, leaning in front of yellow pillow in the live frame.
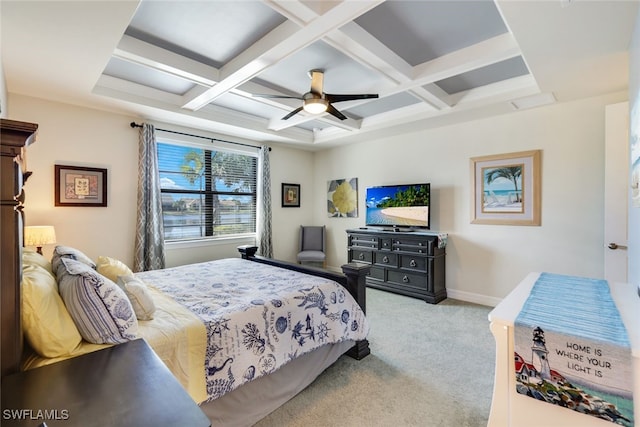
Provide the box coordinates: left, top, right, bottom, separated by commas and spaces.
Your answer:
57, 258, 138, 344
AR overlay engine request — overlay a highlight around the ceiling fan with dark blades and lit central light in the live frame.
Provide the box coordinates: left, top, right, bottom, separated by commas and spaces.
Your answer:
253, 69, 378, 120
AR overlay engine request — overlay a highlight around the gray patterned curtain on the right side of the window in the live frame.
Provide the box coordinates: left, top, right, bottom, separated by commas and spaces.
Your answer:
257, 145, 273, 258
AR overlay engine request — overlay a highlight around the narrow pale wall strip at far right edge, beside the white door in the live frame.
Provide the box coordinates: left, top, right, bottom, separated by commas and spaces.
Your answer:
628, 11, 640, 292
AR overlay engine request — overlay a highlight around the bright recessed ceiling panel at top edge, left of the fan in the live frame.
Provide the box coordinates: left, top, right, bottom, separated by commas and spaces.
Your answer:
125, 1, 286, 67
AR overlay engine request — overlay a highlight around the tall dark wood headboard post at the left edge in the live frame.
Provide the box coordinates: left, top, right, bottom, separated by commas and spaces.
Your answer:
0, 119, 38, 377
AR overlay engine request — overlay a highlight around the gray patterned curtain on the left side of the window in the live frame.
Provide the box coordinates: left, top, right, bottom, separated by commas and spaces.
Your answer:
134, 123, 165, 271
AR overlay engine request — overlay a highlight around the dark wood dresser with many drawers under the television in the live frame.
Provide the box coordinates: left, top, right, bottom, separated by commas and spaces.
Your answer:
347, 229, 447, 304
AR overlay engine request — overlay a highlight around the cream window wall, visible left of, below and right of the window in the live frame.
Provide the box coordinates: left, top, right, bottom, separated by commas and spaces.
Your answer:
9, 94, 313, 266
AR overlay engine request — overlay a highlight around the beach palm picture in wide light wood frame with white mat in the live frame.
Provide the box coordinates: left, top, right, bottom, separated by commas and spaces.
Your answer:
470, 150, 542, 225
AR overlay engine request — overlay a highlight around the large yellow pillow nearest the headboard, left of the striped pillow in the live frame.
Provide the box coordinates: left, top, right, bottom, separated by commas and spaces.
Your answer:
22, 264, 82, 357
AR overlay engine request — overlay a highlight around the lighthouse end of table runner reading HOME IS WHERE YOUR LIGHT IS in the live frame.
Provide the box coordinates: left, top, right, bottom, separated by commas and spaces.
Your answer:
514, 326, 634, 427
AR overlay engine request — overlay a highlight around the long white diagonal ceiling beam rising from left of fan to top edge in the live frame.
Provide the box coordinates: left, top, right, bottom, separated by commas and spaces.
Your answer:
183, 0, 382, 110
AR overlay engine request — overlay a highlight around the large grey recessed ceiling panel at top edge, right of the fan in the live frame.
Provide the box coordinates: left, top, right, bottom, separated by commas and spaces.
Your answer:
355, 0, 508, 66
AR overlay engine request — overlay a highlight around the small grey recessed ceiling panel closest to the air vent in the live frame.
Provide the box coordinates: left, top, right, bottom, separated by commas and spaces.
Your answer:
436, 56, 529, 94
